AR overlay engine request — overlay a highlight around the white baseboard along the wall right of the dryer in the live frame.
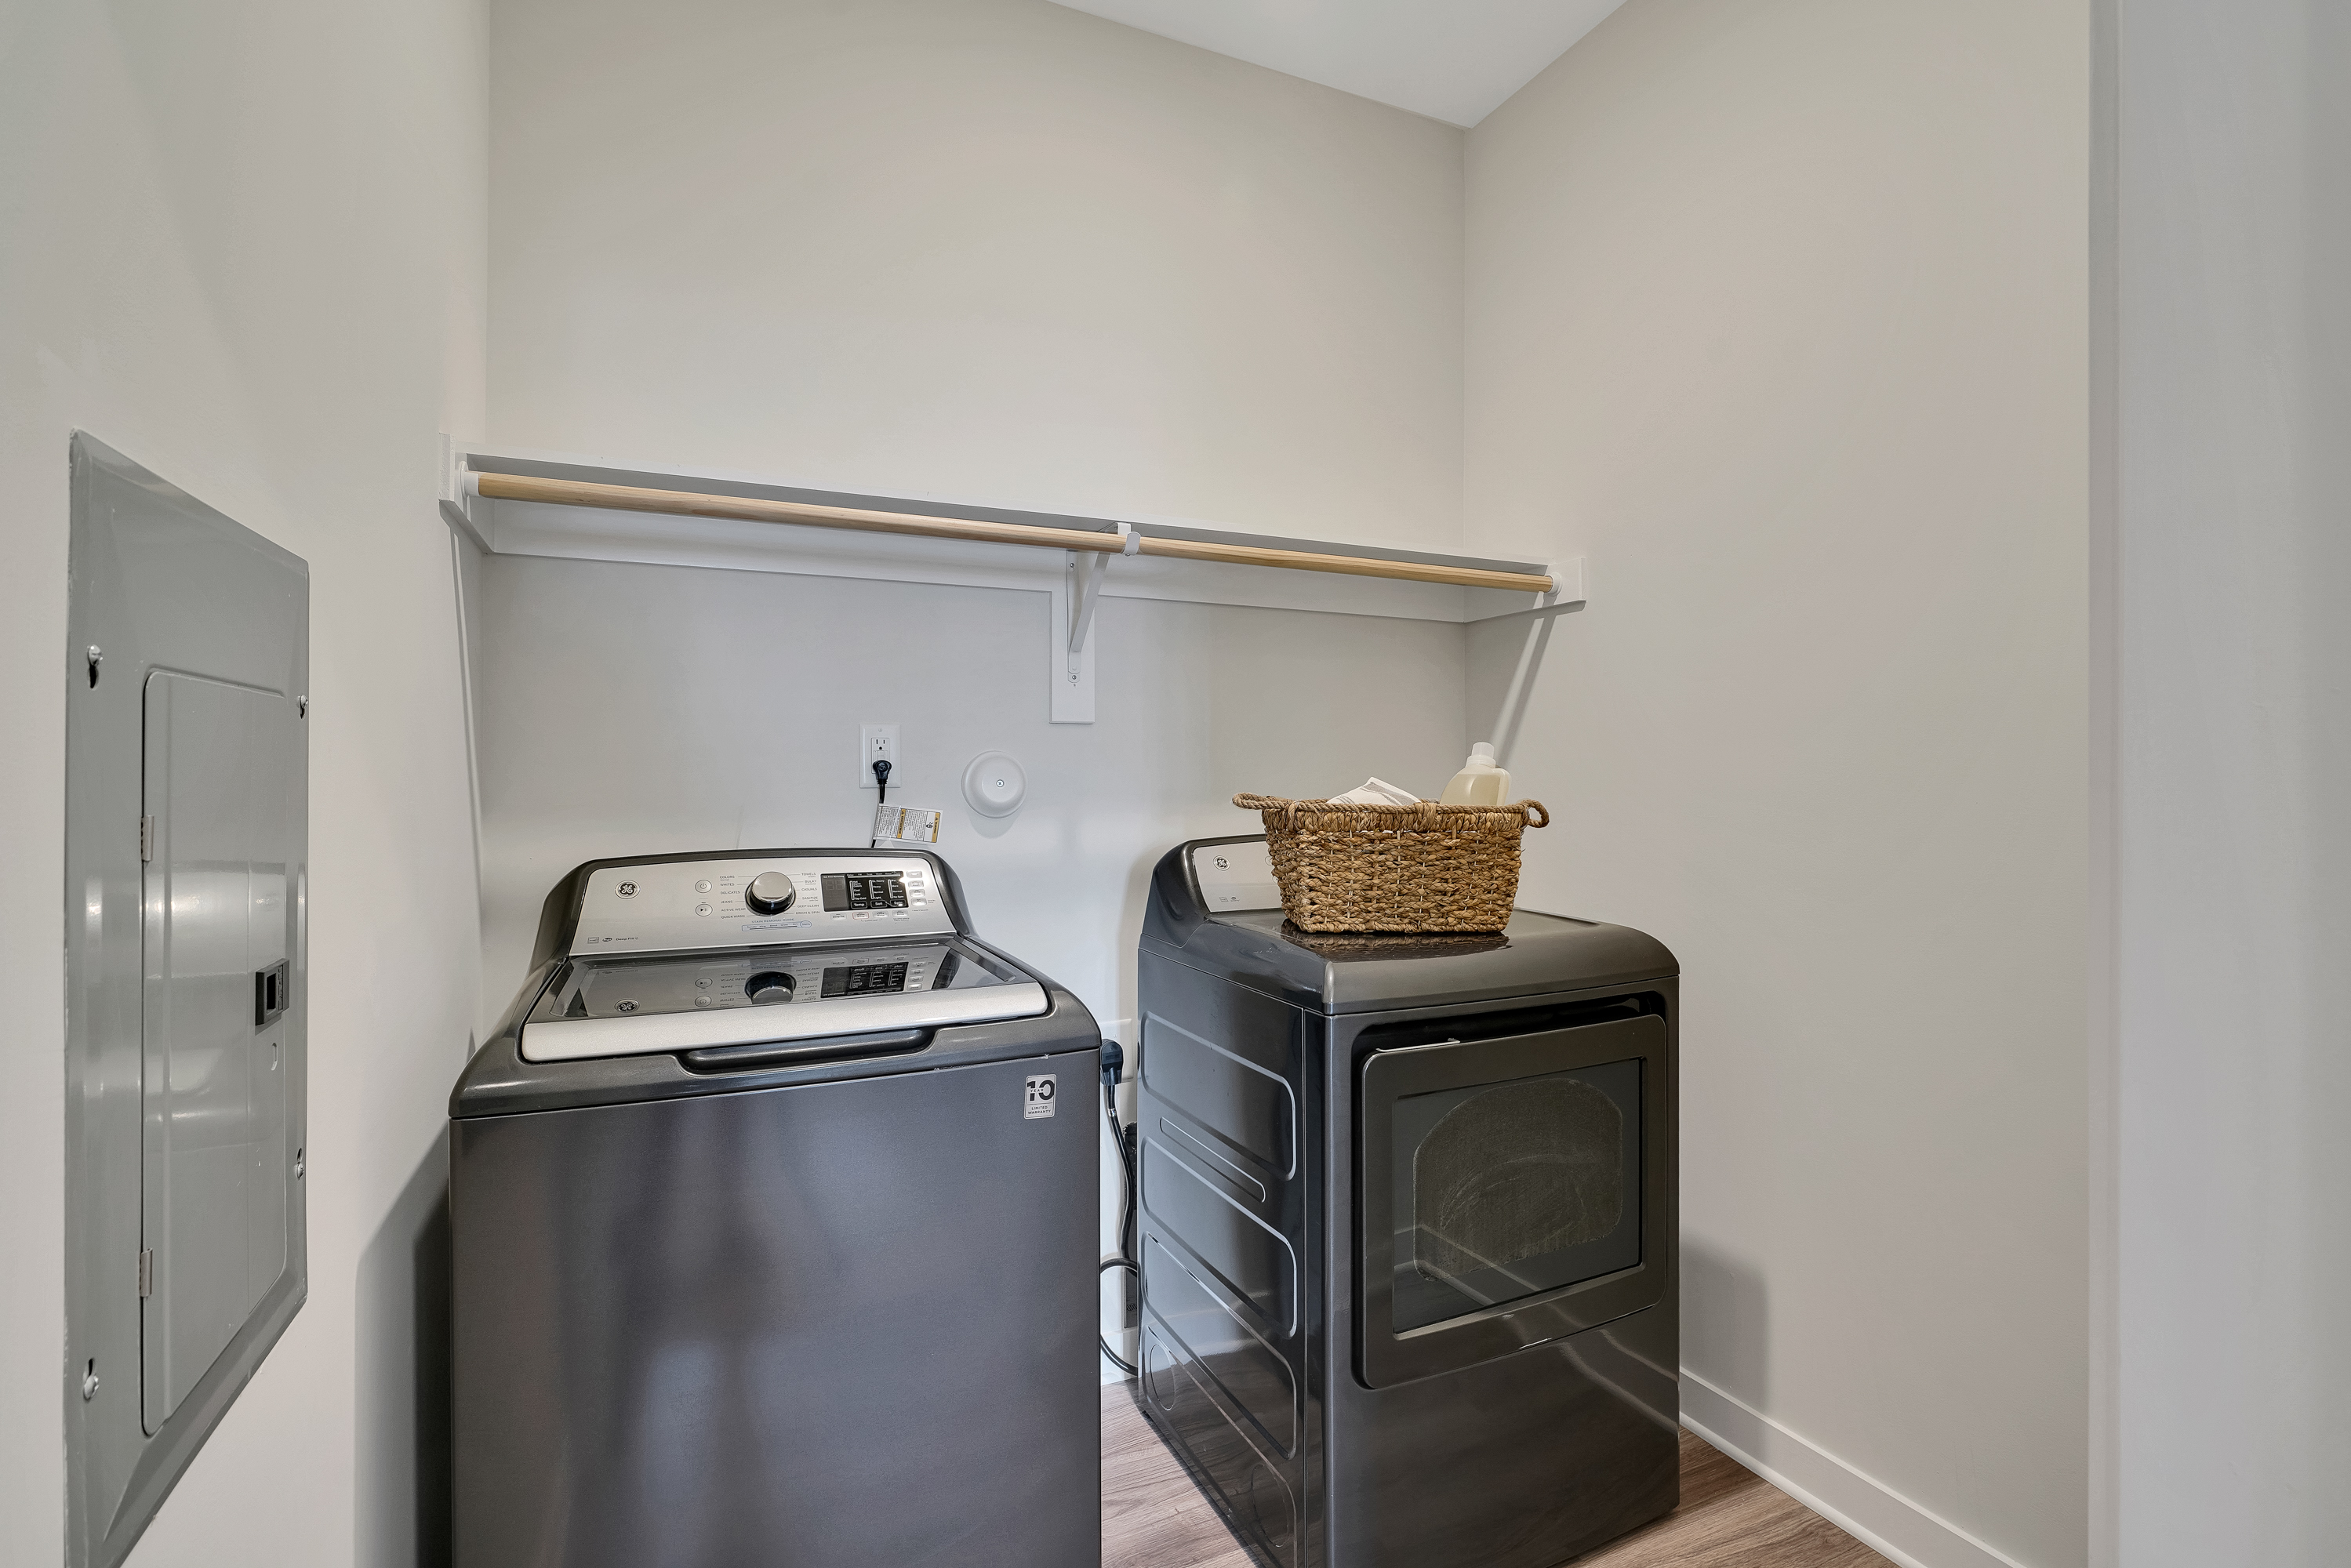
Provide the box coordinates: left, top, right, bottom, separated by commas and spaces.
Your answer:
1681, 1368, 2024, 1568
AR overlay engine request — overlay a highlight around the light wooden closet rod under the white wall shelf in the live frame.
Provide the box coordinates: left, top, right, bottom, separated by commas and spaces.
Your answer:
466, 473, 1552, 593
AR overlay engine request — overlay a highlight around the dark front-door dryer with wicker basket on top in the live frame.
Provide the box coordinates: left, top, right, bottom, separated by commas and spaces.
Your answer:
1136, 837, 1679, 1568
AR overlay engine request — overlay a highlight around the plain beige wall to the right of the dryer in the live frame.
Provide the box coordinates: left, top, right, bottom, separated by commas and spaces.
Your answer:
1467, 0, 2088, 1568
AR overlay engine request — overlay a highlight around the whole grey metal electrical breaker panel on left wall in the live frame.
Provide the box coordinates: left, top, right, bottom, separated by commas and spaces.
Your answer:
64, 435, 311, 1568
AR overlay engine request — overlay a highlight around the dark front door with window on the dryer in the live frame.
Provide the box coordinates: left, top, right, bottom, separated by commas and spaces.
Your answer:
1357, 1013, 1672, 1387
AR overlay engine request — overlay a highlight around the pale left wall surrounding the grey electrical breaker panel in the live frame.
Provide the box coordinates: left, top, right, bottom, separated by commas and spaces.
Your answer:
0, 0, 487, 1568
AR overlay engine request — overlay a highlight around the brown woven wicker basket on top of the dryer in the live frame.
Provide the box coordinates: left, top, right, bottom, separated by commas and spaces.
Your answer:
1232, 794, 1552, 931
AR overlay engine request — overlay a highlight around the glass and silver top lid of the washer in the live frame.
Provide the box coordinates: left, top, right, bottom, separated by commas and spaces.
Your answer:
520, 940, 1046, 1062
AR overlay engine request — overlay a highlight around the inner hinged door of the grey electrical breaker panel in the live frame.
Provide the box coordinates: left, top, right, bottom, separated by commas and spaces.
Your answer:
141, 673, 301, 1432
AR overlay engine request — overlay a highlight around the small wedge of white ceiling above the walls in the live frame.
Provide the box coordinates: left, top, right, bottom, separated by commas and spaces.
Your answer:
1056, 0, 1625, 125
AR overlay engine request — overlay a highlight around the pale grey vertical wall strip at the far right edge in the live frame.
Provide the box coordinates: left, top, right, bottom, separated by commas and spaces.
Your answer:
2097, 0, 2351, 1568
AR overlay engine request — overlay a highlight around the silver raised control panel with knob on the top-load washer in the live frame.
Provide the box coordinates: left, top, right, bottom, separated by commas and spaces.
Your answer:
569, 851, 954, 956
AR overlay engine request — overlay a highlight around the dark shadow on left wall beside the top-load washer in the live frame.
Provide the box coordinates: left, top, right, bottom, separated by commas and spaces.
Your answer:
353, 1128, 449, 1568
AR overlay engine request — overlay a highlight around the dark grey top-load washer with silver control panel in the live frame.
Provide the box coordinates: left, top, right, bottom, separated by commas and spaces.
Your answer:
449, 848, 1100, 1568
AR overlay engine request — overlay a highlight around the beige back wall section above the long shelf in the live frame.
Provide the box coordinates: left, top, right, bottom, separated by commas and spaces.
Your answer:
489, 0, 1463, 543
